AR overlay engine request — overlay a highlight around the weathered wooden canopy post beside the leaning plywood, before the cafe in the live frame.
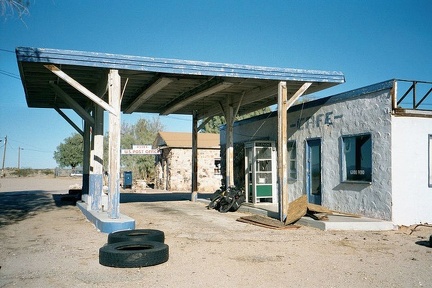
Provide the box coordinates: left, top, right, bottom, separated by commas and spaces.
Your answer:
277, 82, 288, 222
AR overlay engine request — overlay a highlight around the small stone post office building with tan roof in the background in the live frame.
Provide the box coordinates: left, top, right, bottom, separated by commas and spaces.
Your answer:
153, 132, 222, 192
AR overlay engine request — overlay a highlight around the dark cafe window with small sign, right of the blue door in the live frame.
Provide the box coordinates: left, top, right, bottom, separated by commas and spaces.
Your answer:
342, 135, 372, 182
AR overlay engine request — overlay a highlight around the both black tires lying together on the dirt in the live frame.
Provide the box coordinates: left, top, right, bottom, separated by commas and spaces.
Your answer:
99, 229, 169, 268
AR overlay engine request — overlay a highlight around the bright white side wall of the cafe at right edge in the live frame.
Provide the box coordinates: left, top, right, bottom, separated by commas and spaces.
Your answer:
392, 117, 432, 225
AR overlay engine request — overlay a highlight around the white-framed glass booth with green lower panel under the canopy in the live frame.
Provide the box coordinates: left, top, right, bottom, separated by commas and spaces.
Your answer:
245, 141, 278, 204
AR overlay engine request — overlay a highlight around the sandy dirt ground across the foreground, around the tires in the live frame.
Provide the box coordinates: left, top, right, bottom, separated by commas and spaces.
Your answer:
0, 178, 432, 287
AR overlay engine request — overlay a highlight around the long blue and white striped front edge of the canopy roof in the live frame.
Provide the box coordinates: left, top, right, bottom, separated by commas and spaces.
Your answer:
16, 47, 345, 83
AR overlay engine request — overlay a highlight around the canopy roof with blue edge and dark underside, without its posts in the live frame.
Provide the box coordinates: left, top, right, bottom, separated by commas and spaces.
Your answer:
16, 47, 345, 119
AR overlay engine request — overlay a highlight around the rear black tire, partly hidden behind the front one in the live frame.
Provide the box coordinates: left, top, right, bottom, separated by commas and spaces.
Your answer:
108, 229, 165, 244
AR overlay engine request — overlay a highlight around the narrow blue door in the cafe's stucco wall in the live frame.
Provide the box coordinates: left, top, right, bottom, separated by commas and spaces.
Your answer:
306, 139, 321, 205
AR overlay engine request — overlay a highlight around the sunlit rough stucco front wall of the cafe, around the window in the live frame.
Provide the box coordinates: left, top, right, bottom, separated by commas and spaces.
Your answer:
292, 90, 391, 220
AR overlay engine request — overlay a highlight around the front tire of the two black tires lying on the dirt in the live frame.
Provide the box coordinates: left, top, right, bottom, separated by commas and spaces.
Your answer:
99, 241, 169, 268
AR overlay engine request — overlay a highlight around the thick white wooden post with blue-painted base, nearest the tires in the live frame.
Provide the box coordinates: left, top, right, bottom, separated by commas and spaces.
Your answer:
108, 70, 121, 219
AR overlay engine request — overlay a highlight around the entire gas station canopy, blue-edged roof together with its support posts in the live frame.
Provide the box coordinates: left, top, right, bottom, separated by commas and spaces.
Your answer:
16, 47, 345, 223
